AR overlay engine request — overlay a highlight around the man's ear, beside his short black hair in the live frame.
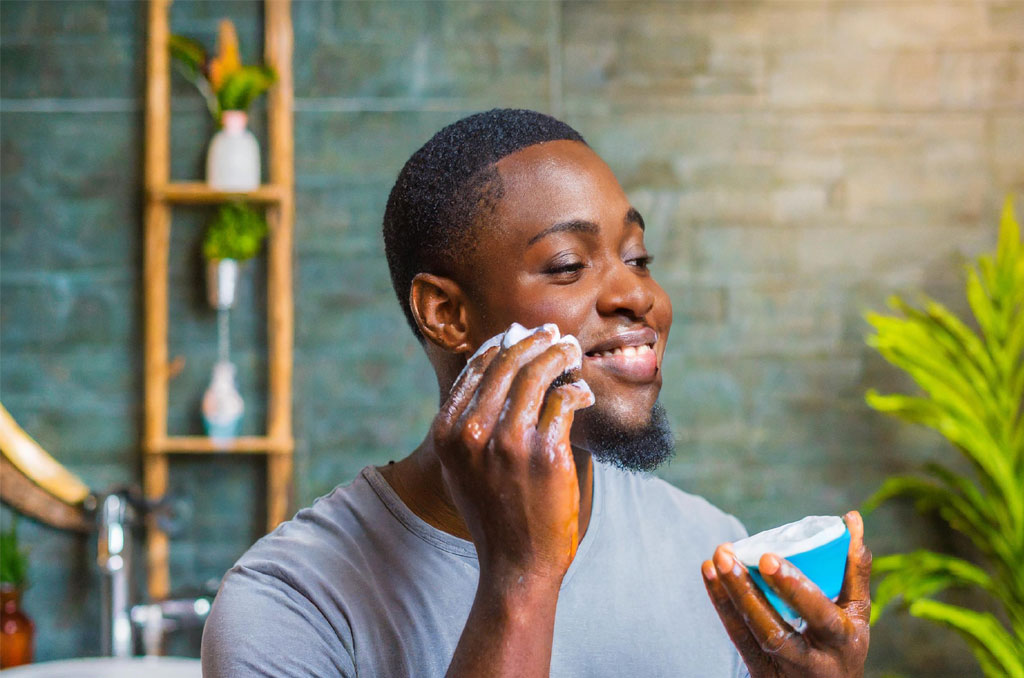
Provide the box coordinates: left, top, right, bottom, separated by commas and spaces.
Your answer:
409, 273, 469, 353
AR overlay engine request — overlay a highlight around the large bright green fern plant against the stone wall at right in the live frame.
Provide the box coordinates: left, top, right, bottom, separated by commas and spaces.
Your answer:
864, 199, 1024, 678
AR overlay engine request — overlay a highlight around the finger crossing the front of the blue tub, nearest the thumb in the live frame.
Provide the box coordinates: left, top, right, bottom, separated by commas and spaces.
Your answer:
758, 553, 853, 646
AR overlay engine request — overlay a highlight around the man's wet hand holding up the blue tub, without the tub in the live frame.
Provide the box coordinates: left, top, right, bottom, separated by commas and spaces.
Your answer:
700, 511, 871, 678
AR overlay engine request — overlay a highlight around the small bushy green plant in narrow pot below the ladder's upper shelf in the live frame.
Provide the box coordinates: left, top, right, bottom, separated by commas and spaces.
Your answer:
203, 202, 267, 310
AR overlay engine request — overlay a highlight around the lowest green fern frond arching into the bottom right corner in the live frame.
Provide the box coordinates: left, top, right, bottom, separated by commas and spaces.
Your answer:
909, 598, 1024, 678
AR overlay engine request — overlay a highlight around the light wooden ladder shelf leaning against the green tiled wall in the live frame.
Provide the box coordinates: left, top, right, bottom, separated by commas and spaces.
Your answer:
142, 0, 295, 599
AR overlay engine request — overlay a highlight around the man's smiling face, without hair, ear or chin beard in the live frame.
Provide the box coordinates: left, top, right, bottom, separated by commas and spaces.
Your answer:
462, 141, 672, 447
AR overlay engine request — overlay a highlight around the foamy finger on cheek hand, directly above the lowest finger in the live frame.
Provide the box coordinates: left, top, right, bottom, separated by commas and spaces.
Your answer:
499, 337, 583, 439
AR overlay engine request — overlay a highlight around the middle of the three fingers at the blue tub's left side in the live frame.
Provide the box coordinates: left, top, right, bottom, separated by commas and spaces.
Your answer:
714, 544, 804, 660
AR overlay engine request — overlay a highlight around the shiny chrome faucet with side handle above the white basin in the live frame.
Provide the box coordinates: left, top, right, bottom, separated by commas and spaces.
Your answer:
96, 491, 211, 656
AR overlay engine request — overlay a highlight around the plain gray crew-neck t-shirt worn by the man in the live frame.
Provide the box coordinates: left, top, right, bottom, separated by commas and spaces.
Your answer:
203, 464, 746, 678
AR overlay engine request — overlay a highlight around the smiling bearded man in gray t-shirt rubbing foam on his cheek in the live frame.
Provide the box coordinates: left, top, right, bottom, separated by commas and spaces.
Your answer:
203, 110, 870, 678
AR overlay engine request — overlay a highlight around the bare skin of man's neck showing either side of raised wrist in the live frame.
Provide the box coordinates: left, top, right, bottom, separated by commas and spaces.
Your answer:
379, 436, 594, 542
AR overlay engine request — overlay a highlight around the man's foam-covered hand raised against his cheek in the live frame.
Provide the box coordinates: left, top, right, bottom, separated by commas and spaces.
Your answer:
433, 326, 594, 581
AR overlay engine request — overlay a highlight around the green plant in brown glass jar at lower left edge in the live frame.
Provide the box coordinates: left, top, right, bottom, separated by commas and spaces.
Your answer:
0, 521, 35, 669
